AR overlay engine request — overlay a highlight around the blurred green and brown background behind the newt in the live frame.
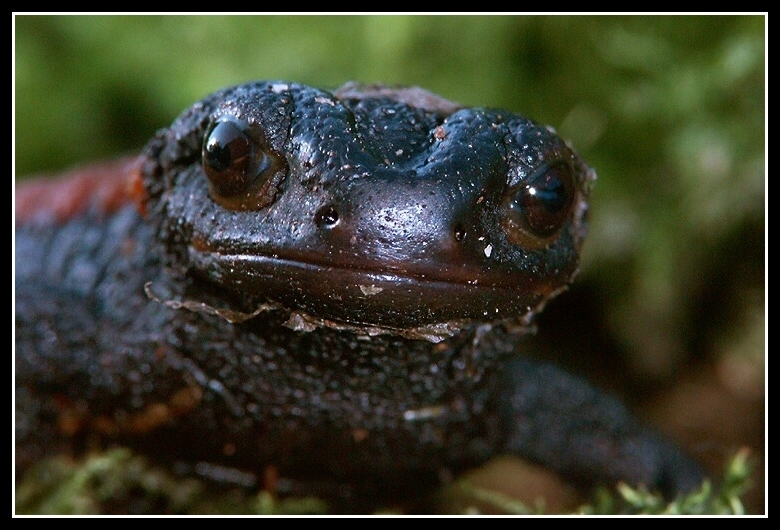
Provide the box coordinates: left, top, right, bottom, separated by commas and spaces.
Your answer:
13, 15, 767, 513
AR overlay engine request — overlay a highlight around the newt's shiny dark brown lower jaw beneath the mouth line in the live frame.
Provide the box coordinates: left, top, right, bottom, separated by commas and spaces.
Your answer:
190, 248, 565, 330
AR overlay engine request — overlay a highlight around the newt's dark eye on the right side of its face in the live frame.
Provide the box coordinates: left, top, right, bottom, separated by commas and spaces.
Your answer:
502, 162, 575, 248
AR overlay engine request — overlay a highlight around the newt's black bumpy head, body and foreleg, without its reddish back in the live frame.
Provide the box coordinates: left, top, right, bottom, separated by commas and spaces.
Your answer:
16, 82, 702, 510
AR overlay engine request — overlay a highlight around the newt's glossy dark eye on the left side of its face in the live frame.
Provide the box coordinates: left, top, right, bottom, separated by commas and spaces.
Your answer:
202, 120, 284, 210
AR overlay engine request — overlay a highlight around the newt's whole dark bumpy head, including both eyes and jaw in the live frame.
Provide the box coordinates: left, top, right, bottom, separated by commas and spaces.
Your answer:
144, 82, 595, 336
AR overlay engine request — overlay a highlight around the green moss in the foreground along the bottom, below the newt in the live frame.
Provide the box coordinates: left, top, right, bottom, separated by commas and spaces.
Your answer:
15, 449, 751, 515
